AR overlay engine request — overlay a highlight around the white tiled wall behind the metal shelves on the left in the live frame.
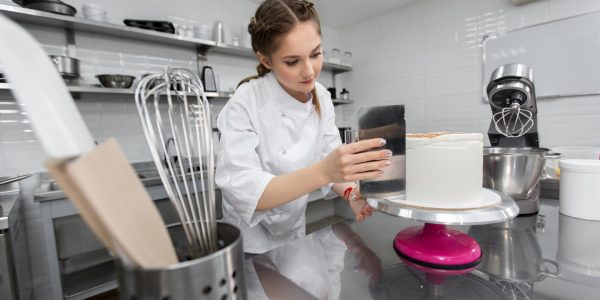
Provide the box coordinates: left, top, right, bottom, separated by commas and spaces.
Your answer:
0, 0, 340, 176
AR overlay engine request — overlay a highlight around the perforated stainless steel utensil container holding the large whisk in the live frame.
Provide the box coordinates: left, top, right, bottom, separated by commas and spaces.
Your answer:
117, 223, 246, 300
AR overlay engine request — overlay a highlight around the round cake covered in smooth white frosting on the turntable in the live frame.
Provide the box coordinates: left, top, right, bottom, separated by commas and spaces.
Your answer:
406, 133, 482, 209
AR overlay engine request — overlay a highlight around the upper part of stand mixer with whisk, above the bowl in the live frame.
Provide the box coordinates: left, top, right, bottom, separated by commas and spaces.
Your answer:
487, 64, 538, 147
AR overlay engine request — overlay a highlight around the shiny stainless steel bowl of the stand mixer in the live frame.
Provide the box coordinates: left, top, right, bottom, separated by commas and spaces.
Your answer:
483, 147, 560, 199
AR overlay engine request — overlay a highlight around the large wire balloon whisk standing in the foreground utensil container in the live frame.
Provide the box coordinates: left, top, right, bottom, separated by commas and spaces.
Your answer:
135, 69, 218, 257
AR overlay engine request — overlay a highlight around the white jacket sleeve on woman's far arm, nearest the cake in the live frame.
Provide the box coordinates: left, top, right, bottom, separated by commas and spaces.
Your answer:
319, 93, 342, 199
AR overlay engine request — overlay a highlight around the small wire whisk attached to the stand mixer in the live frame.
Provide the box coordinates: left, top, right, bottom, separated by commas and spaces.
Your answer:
492, 101, 534, 138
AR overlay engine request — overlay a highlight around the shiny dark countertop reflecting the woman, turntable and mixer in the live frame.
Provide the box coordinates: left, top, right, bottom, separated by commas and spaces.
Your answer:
245, 200, 600, 300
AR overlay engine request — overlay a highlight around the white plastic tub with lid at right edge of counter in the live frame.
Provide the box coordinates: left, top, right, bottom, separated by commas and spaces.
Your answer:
559, 159, 600, 220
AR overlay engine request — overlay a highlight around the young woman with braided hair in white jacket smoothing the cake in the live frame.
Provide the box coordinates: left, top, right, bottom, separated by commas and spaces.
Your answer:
216, 0, 391, 253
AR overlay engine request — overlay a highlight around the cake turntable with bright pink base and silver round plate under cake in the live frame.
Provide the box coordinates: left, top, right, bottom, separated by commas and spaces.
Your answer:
367, 188, 519, 284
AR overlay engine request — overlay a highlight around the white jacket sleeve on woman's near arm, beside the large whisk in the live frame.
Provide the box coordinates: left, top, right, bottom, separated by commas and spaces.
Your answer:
215, 99, 275, 226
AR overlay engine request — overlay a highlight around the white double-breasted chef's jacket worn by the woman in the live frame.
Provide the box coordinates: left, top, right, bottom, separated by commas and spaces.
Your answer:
215, 73, 341, 253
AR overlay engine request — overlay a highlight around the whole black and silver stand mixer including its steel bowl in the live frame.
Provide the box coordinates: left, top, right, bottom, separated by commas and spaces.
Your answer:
484, 64, 549, 214
